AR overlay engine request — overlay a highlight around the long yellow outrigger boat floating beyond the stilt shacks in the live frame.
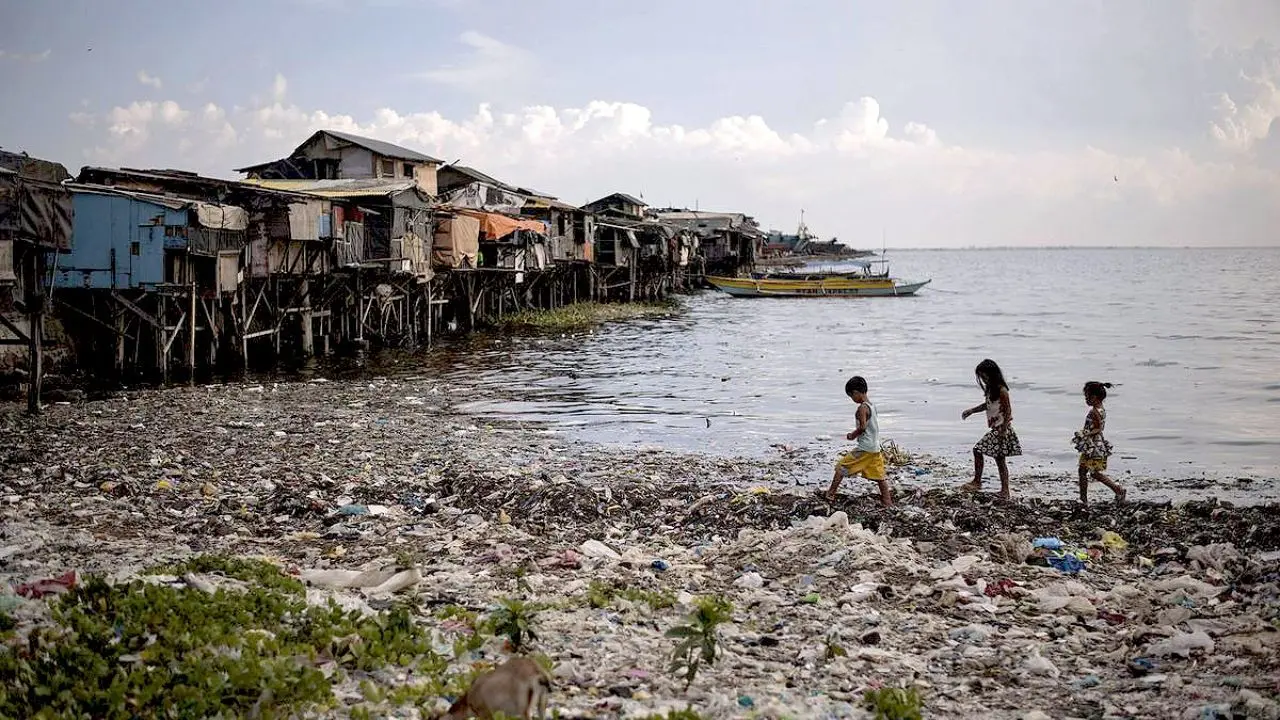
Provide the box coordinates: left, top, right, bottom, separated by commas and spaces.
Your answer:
707, 260, 931, 297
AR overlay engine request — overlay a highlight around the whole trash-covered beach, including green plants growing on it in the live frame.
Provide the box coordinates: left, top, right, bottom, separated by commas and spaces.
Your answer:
0, 377, 1280, 719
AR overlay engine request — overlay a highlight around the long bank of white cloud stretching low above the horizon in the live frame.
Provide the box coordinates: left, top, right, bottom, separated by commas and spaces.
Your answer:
70, 84, 1280, 246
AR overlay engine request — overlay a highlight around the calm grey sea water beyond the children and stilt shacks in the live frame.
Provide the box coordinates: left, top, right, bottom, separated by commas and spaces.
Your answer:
419, 249, 1280, 500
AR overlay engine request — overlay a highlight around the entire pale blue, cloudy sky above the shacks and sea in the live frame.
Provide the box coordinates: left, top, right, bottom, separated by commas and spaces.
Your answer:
0, 0, 1280, 247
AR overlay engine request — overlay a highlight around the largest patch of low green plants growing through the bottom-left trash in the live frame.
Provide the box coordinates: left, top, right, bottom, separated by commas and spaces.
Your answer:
0, 556, 465, 720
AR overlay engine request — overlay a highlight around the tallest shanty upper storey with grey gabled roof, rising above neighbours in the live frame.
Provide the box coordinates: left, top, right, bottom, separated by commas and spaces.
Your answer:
237, 129, 442, 196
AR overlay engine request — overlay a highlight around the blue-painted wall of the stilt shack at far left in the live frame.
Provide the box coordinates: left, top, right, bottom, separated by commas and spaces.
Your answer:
54, 190, 188, 290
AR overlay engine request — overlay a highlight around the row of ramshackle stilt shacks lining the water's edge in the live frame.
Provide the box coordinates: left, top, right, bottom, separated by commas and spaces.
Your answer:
0, 131, 849, 410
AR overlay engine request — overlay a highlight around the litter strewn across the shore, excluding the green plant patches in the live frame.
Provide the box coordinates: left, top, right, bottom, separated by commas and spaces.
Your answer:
0, 378, 1280, 719
